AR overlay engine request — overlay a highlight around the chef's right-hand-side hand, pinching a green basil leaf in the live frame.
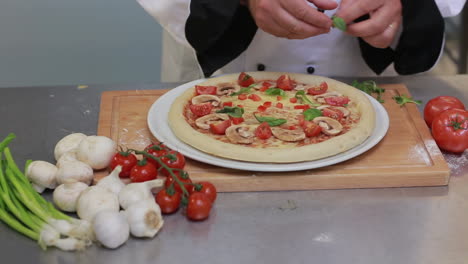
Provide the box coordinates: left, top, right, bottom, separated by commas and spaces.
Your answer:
336, 0, 402, 48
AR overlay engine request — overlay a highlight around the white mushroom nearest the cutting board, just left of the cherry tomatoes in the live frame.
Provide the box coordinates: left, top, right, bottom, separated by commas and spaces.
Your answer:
76, 136, 117, 170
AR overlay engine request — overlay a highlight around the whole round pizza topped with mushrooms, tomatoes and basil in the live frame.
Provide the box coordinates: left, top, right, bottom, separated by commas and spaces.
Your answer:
168, 72, 375, 163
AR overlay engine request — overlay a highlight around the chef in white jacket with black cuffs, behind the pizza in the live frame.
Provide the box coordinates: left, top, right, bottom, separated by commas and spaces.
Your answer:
138, 0, 465, 81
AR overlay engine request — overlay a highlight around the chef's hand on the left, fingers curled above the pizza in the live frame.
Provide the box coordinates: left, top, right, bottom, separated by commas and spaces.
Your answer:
248, 0, 338, 39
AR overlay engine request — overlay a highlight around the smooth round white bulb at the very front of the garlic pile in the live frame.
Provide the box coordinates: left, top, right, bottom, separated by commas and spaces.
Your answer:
93, 210, 130, 248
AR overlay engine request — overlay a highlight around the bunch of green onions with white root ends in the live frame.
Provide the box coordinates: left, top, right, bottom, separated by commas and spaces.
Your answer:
0, 134, 93, 251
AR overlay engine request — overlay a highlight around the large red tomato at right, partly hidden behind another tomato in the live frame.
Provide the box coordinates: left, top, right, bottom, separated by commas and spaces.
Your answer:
424, 96, 465, 127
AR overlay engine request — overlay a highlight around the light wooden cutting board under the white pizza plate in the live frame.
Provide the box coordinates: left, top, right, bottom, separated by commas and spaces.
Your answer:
97, 84, 450, 192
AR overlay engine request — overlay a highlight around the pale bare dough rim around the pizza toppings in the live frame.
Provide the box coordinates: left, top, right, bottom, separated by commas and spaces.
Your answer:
168, 72, 375, 163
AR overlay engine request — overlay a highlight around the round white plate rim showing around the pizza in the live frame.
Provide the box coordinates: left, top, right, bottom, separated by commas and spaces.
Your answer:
147, 79, 389, 172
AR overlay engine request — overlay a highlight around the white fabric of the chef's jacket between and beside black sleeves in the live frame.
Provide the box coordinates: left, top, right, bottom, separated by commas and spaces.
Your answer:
137, 0, 465, 82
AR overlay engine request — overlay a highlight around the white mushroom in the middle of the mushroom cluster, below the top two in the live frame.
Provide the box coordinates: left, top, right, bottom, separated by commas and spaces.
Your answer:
56, 161, 94, 185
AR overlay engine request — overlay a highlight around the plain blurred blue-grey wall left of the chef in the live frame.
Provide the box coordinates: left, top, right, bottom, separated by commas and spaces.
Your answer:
0, 0, 161, 87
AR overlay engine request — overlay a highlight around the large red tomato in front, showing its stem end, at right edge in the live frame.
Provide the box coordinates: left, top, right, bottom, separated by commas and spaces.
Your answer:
432, 109, 468, 153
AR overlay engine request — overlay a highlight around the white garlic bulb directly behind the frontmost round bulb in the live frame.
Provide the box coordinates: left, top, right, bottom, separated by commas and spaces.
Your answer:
76, 186, 120, 222
